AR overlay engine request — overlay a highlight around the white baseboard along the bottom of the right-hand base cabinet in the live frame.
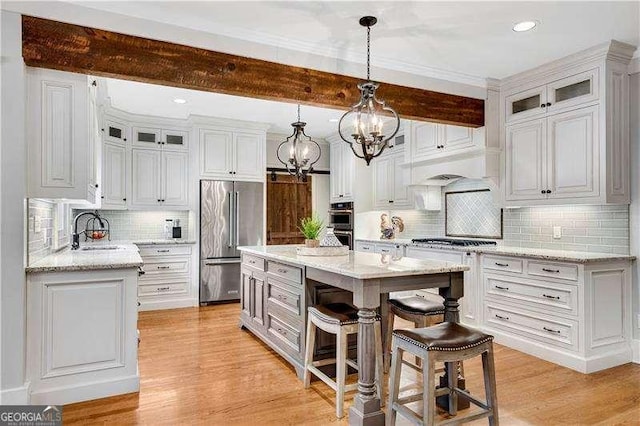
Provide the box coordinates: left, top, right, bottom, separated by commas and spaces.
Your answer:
483, 329, 633, 374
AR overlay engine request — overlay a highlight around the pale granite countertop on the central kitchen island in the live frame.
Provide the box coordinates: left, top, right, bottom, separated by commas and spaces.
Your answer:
238, 245, 470, 279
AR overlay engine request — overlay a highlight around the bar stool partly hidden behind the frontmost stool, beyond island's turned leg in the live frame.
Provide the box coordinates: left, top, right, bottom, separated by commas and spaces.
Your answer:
384, 296, 444, 373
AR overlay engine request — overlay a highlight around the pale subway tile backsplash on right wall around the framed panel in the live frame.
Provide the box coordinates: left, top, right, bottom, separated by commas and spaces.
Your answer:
372, 179, 630, 254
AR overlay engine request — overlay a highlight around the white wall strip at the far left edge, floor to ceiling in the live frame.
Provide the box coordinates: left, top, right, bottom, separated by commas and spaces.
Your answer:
0, 11, 27, 404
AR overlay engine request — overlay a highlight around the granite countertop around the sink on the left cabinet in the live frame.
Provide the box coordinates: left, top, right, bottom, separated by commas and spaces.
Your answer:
25, 244, 143, 272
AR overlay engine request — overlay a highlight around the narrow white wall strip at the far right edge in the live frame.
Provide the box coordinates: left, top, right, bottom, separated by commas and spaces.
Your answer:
629, 67, 640, 350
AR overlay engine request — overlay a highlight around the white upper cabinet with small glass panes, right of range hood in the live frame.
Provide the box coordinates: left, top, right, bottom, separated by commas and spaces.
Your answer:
501, 42, 633, 206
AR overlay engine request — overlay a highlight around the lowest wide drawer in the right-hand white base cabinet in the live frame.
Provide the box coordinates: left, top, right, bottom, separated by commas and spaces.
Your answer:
485, 305, 578, 350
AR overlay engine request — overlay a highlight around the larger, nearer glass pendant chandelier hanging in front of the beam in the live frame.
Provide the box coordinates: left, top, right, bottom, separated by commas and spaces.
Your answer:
338, 16, 400, 165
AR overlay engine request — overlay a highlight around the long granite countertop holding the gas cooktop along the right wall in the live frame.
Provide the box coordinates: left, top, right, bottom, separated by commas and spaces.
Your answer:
356, 238, 636, 263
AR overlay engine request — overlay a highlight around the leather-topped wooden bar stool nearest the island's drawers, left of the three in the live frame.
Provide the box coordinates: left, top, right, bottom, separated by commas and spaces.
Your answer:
304, 303, 384, 418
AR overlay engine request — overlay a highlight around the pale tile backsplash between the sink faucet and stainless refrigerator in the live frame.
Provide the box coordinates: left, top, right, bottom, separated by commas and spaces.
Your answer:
74, 210, 189, 241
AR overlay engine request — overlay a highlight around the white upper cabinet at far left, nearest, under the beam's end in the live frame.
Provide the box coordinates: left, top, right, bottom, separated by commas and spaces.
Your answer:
27, 68, 100, 204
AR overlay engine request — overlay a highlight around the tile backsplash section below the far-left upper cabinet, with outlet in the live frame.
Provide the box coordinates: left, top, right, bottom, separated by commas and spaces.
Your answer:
27, 198, 56, 264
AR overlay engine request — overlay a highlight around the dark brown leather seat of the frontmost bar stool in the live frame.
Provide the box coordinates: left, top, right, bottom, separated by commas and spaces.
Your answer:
393, 322, 493, 351
